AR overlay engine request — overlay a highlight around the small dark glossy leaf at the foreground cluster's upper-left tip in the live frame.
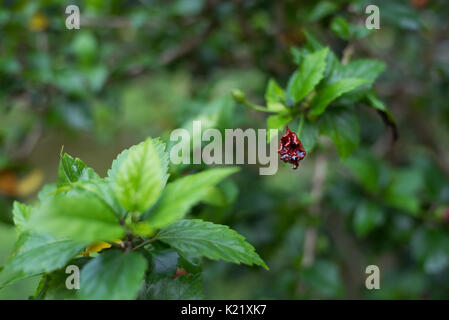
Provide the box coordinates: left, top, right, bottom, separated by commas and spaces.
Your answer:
58, 153, 99, 188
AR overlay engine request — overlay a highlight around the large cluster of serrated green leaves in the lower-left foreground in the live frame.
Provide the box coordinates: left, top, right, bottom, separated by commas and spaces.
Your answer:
0, 138, 267, 299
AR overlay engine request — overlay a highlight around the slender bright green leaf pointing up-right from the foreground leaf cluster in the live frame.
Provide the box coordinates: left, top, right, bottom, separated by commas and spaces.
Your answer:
147, 168, 238, 230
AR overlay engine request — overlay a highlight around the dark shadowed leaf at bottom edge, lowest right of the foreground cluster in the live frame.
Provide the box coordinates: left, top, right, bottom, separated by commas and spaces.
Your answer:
143, 274, 203, 300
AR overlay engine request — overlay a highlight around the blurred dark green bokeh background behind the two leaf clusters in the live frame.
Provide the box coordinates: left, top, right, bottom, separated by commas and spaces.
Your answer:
0, 0, 449, 299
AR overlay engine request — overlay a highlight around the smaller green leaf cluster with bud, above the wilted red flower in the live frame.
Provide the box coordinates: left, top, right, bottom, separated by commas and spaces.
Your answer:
234, 34, 394, 159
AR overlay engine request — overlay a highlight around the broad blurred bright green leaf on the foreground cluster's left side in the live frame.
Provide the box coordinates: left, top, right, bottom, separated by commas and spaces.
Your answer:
29, 192, 124, 241
